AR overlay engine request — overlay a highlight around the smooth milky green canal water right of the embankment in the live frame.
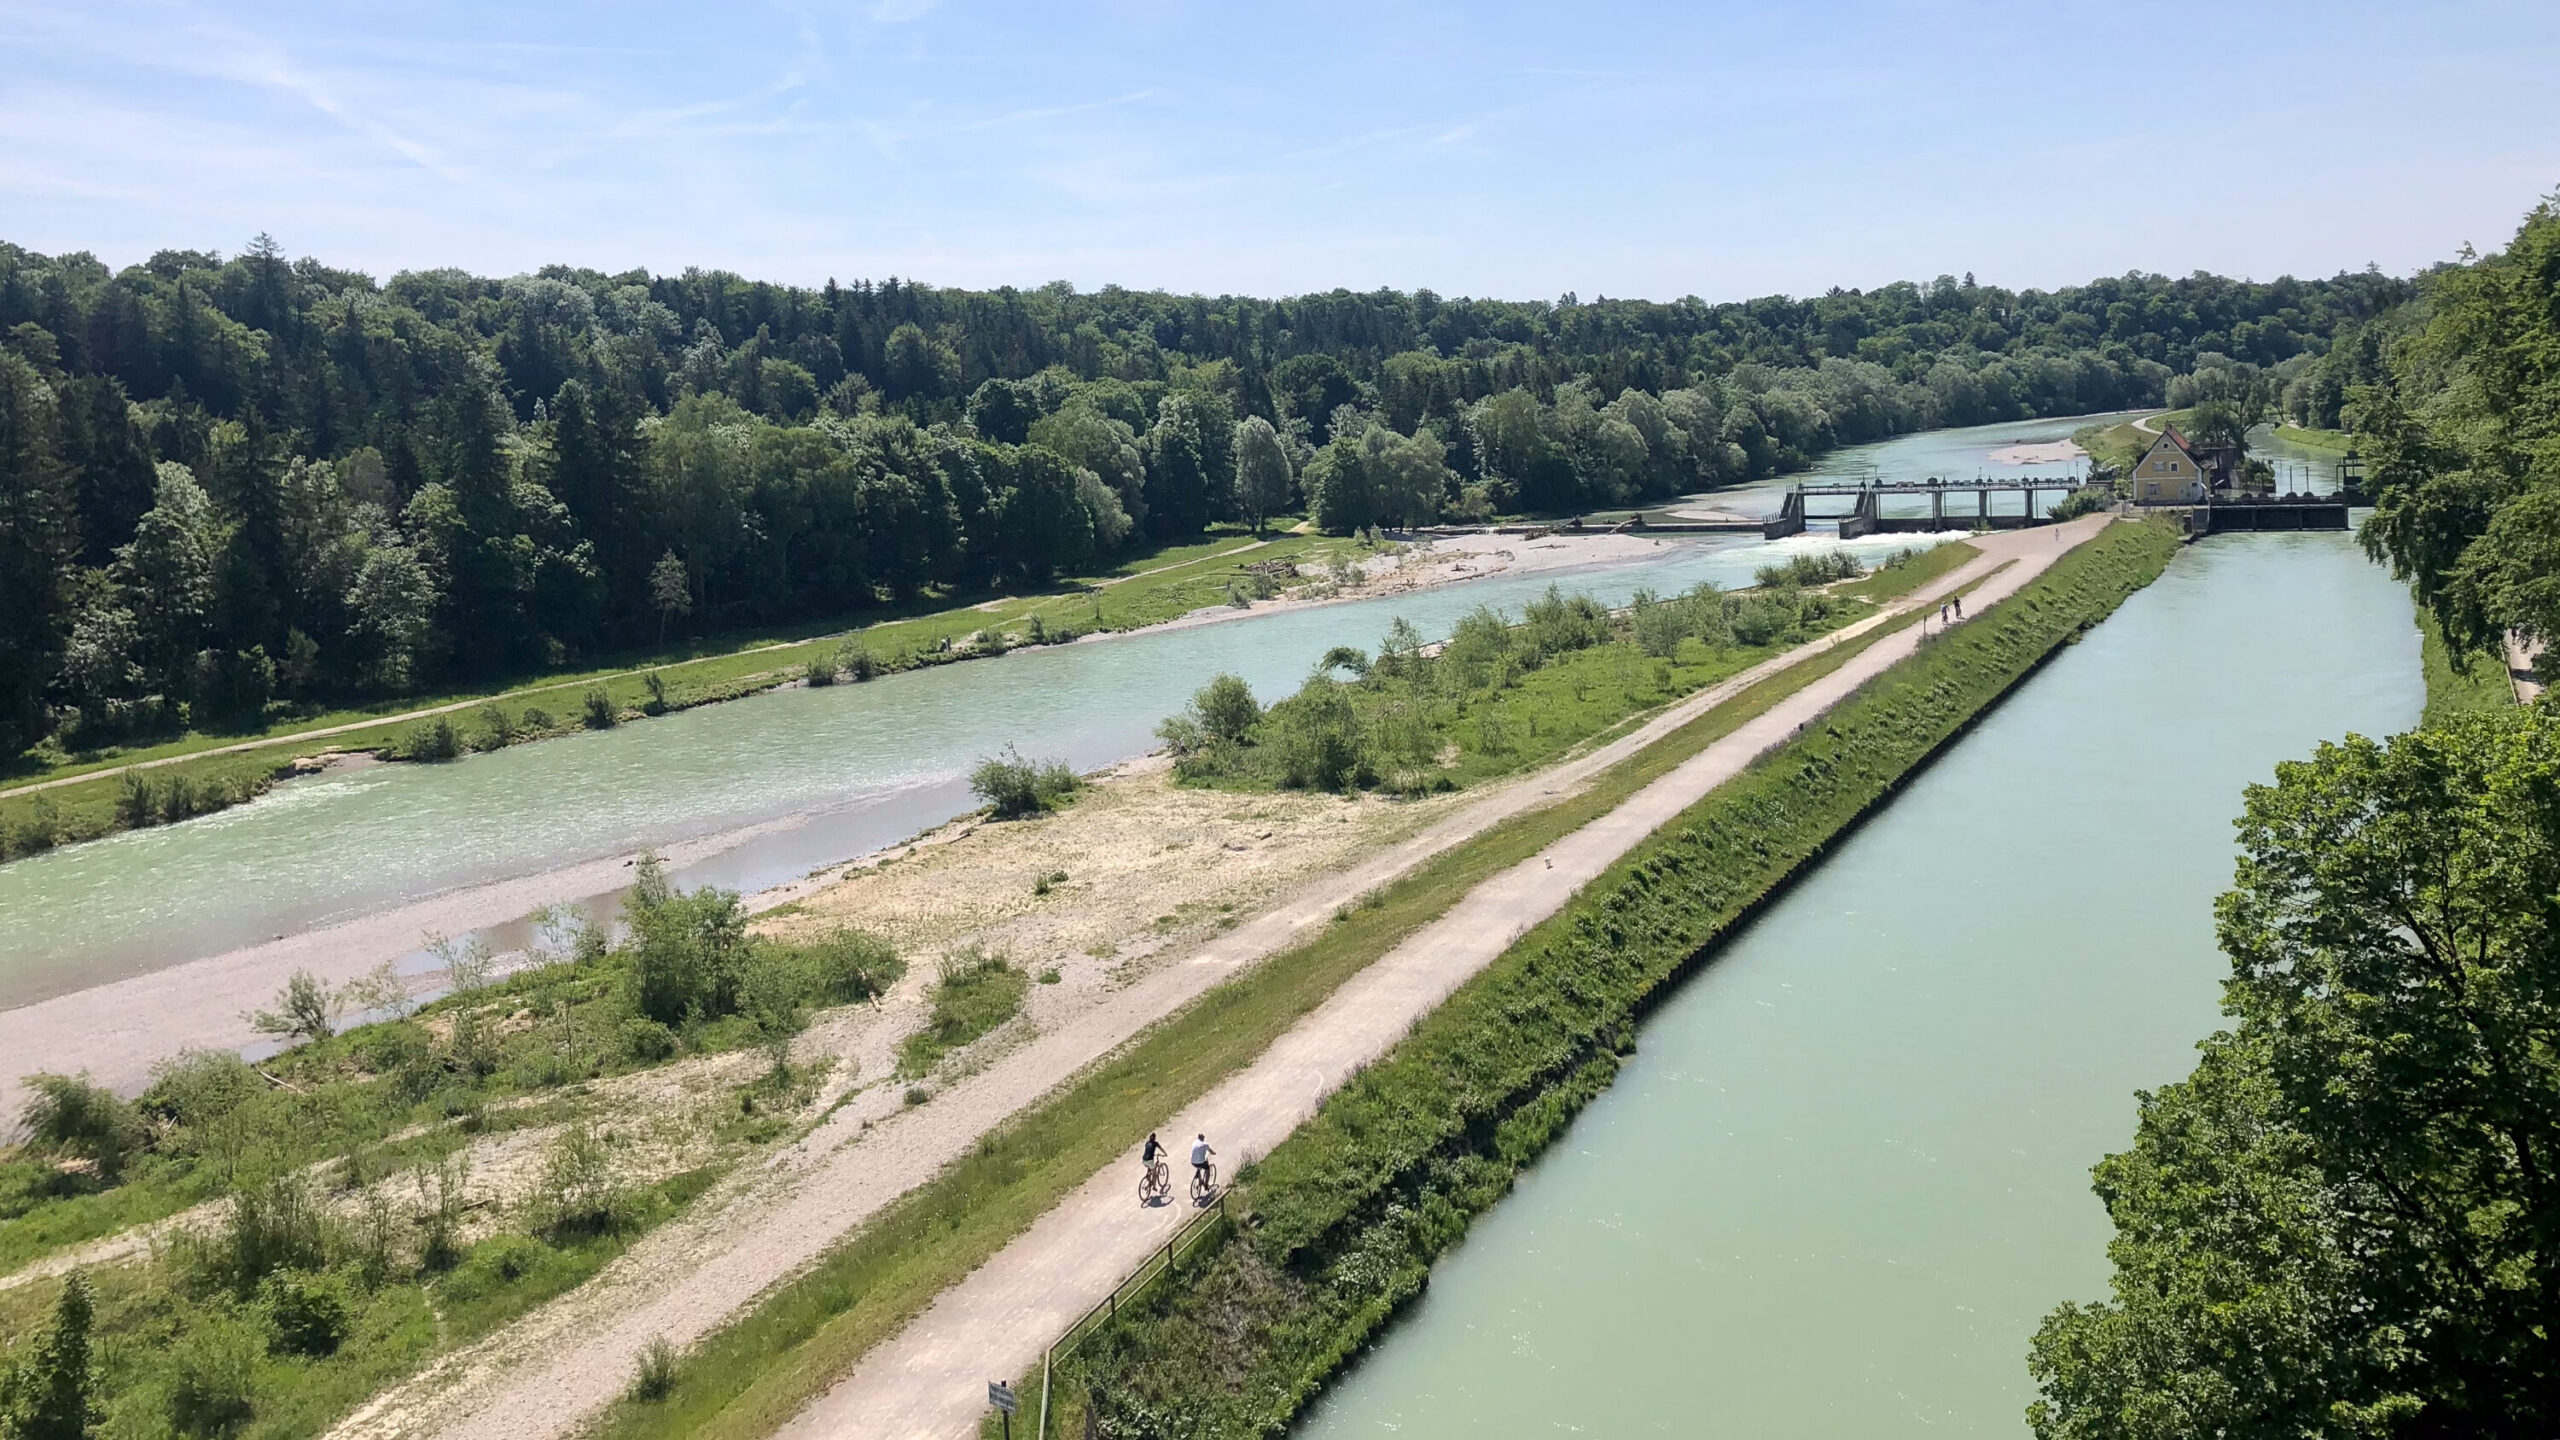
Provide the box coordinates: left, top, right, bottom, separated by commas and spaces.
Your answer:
1300, 533, 2422, 1440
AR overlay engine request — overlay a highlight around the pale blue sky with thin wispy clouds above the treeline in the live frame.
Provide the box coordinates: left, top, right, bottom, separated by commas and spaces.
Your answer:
0, 0, 2560, 300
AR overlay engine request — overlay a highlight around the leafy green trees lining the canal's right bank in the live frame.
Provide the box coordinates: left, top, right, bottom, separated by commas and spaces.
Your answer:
2028, 188, 2560, 1440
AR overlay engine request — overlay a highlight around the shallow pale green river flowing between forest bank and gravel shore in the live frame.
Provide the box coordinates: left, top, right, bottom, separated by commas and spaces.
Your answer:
0, 404, 2119, 1010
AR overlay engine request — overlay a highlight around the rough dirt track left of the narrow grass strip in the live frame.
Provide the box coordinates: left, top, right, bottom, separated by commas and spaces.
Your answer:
314, 525, 2094, 1440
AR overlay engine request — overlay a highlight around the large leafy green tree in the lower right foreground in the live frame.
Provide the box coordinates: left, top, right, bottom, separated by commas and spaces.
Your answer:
2030, 710, 2560, 1440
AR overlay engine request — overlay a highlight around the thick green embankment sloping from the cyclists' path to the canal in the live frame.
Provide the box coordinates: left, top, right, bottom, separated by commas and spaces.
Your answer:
1027, 515, 2179, 1437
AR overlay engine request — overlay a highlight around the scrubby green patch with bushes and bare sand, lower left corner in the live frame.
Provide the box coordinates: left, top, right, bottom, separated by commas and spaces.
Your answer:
0, 892, 901, 1437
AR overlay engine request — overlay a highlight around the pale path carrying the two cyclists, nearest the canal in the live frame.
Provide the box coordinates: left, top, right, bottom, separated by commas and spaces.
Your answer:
768, 515, 2107, 1440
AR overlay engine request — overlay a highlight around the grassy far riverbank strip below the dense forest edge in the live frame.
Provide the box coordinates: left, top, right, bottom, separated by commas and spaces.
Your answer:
0, 533, 1352, 858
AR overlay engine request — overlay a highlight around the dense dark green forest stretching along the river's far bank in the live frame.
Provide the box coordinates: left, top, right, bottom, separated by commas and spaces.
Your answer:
0, 236, 2409, 756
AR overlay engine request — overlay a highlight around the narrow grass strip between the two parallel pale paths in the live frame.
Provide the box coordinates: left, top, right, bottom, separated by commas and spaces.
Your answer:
594, 535, 1974, 1440
